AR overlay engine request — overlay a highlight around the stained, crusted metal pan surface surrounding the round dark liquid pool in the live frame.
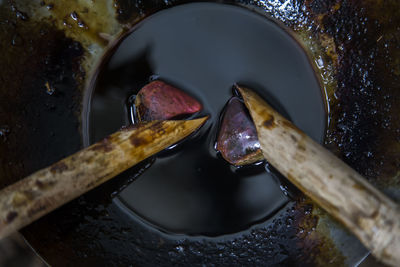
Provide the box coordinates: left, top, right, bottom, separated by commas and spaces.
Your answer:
0, 0, 400, 266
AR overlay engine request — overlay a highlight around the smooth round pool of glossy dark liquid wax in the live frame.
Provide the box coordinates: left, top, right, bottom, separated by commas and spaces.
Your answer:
86, 3, 327, 236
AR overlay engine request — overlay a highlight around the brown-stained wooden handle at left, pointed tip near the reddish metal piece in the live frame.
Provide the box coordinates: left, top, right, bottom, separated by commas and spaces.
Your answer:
0, 118, 208, 238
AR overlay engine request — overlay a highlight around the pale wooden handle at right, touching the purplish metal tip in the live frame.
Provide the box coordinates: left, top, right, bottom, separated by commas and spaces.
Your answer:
238, 88, 400, 266
